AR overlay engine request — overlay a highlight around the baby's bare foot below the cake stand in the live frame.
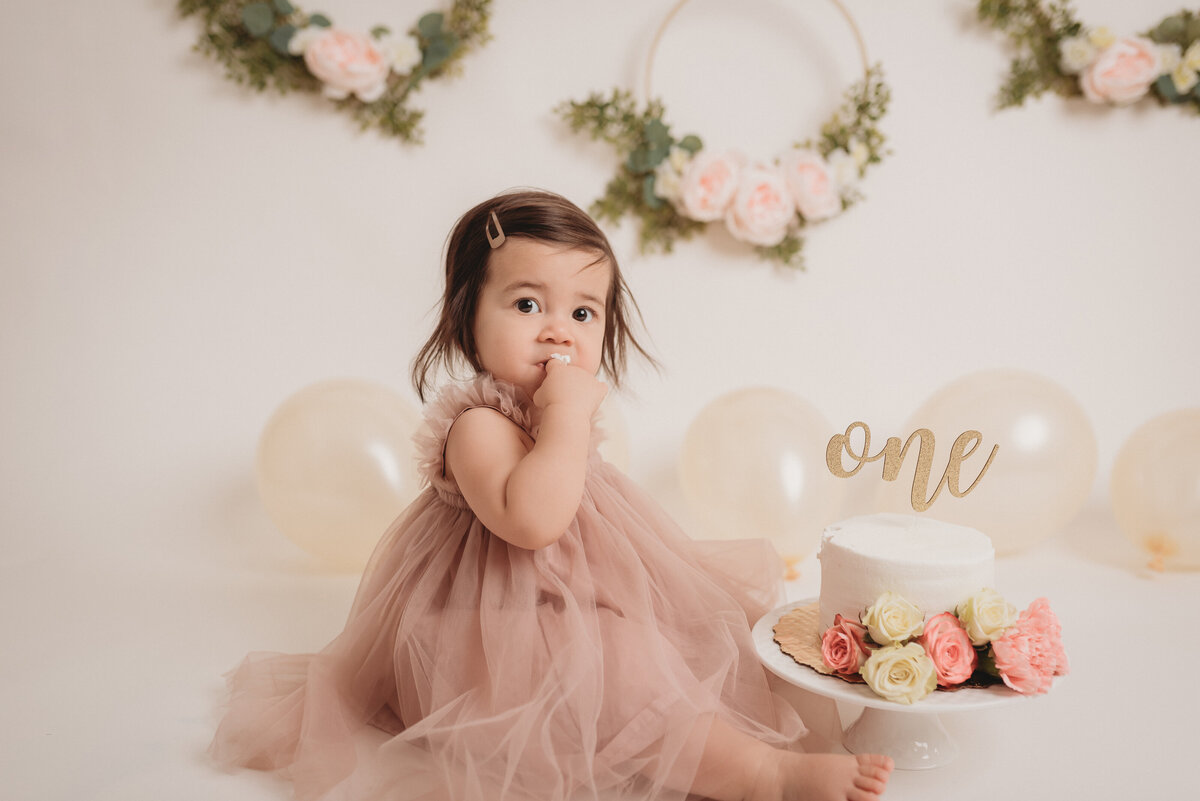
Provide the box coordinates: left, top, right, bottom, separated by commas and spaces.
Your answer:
752, 753, 893, 801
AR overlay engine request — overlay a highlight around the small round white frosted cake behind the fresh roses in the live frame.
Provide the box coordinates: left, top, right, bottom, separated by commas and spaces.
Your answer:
817, 514, 995, 633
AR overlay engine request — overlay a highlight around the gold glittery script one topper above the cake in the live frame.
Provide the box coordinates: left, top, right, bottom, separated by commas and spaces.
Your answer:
826, 422, 1000, 512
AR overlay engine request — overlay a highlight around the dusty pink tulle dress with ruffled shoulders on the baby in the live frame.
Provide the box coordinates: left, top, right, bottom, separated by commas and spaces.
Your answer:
210, 375, 803, 801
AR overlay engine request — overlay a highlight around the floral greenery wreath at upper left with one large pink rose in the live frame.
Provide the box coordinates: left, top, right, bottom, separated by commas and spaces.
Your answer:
176, 0, 491, 144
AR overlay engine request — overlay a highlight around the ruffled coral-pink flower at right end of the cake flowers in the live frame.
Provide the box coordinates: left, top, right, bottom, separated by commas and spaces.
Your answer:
991, 598, 1067, 694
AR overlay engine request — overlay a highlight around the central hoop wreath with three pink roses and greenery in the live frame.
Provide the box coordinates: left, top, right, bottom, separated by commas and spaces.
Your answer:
557, 0, 890, 269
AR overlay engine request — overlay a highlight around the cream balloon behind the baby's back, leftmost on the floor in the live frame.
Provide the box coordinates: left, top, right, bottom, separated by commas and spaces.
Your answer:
257, 379, 420, 571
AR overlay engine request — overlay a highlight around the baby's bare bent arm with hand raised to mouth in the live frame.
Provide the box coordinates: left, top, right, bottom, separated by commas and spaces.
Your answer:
446, 361, 607, 549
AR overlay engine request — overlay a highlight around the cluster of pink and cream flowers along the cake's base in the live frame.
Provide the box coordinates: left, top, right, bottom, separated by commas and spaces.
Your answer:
821, 588, 1068, 704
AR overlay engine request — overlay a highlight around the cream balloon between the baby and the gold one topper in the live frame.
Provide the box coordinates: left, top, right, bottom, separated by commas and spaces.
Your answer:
679, 387, 842, 562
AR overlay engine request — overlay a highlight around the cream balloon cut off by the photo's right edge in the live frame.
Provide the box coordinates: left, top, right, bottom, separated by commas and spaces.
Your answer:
1110, 408, 1200, 568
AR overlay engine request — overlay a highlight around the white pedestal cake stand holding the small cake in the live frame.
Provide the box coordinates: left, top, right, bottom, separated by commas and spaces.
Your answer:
754, 598, 1026, 770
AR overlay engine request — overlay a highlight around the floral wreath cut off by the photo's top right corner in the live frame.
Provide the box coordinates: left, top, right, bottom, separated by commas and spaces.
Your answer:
978, 0, 1200, 112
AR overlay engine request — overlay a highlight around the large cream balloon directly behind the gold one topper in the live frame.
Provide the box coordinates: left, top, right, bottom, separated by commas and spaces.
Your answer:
860, 369, 1097, 554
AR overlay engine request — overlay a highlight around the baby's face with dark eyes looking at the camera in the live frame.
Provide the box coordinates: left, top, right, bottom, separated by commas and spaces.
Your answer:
475, 236, 612, 397
